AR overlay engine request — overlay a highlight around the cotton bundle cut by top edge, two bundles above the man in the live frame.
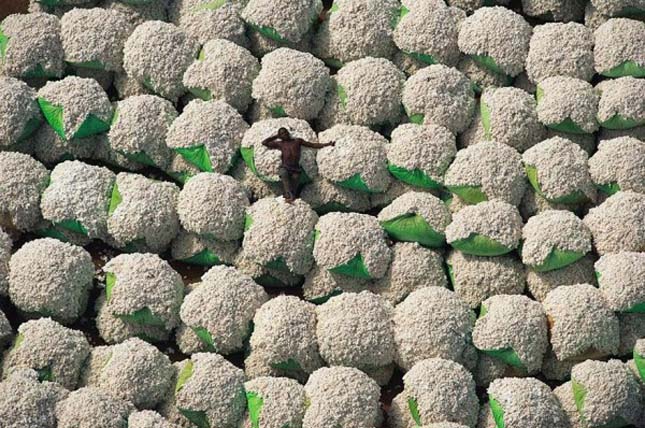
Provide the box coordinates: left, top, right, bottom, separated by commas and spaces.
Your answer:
241, 0, 323, 43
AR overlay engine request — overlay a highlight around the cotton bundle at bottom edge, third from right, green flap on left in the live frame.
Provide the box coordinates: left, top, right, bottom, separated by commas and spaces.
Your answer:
389, 358, 479, 427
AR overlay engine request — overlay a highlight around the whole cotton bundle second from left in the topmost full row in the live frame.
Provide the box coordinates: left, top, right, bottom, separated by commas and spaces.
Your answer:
60, 7, 132, 71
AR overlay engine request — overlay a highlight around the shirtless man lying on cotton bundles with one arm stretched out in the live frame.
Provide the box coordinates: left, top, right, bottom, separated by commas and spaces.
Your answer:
262, 128, 336, 203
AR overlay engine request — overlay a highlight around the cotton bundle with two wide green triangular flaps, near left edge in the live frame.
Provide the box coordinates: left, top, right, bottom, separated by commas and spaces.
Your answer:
38, 76, 114, 140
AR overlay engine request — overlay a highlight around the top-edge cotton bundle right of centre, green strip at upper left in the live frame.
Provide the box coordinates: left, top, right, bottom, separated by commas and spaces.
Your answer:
394, 0, 466, 67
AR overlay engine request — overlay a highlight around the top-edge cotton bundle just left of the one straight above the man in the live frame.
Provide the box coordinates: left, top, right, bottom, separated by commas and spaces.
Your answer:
169, 0, 249, 47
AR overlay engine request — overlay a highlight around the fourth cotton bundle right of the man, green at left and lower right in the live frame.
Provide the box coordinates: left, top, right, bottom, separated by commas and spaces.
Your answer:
522, 137, 596, 205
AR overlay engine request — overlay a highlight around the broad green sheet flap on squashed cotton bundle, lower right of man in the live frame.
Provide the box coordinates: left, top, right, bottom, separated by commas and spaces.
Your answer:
381, 213, 446, 248
